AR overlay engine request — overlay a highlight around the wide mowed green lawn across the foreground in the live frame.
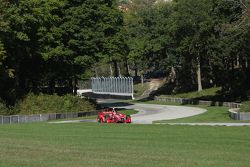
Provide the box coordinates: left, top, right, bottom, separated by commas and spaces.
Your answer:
0, 123, 250, 167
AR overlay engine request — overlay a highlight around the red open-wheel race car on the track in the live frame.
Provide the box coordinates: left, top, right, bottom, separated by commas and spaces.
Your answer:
97, 108, 131, 123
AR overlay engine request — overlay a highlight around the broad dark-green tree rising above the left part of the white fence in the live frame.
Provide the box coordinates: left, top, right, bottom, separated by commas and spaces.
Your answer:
56, 0, 124, 86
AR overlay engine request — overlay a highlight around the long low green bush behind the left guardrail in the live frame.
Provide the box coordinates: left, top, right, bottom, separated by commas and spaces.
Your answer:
16, 94, 95, 114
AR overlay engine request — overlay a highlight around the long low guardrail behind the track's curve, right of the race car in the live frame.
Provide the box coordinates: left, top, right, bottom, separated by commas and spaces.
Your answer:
154, 96, 241, 108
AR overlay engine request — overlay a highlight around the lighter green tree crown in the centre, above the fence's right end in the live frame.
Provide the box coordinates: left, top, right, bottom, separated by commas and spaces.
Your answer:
125, 1, 172, 75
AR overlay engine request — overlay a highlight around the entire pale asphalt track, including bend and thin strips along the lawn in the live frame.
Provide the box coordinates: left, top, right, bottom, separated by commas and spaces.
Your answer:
49, 100, 250, 126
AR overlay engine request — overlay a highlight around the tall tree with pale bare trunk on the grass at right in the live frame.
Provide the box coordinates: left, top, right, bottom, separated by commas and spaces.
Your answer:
173, 0, 218, 91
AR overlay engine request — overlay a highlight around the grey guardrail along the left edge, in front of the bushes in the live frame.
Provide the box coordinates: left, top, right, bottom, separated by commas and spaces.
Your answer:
0, 111, 98, 124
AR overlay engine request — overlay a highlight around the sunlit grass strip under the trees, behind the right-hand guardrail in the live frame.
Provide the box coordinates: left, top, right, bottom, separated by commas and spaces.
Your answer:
160, 87, 221, 98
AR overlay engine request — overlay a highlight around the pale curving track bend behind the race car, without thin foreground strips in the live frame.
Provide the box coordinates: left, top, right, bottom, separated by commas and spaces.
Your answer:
98, 100, 206, 124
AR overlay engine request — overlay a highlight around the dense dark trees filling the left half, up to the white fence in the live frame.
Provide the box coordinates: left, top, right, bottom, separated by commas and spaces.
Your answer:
0, 0, 123, 105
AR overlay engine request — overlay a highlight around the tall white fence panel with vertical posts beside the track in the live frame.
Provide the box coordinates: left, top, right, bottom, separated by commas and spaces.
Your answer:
91, 77, 134, 98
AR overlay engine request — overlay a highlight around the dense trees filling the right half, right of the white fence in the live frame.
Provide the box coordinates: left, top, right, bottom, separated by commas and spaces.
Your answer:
126, 0, 250, 100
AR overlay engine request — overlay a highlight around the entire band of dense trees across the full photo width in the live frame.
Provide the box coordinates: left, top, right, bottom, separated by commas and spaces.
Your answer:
0, 0, 250, 113
